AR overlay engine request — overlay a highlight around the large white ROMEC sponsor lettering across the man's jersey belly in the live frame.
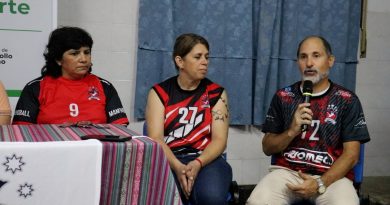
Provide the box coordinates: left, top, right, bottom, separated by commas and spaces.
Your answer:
283, 148, 334, 168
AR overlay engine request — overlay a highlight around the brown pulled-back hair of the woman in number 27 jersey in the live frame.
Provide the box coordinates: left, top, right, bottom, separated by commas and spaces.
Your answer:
172, 33, 210, 69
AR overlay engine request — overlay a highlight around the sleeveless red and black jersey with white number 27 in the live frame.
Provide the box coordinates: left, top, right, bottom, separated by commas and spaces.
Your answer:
153, 76, 224, 154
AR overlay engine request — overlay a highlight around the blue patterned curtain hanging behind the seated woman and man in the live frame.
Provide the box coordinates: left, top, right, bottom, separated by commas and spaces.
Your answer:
134, 0, 360, 125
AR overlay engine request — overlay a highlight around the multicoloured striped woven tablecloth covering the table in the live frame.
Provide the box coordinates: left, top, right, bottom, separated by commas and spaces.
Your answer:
0, 124, 182, 205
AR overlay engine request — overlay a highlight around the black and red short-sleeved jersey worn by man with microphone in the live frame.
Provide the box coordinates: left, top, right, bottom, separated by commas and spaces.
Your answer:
262, 82, 370, 179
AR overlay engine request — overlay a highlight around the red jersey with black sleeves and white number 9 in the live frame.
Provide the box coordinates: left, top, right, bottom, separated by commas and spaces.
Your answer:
13, 74, 128, 124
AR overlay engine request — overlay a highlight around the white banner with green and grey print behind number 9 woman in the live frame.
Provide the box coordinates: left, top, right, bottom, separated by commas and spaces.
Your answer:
0, 0, 57, 97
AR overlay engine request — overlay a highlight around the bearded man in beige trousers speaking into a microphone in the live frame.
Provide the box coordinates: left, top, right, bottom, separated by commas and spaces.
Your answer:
247, 36, 370, 205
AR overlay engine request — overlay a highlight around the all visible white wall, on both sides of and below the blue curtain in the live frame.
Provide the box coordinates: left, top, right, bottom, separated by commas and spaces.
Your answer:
58, 0, 390, 185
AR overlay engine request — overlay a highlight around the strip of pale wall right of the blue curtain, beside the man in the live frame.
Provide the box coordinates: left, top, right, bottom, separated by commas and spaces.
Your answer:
356, 0, 390, 176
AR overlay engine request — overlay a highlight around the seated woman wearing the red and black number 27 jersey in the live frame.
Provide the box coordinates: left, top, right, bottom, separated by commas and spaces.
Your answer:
146, 34, 232, 205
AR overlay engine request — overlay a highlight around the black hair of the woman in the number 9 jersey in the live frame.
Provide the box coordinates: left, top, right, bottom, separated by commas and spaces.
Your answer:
41, 27, 93, 78
